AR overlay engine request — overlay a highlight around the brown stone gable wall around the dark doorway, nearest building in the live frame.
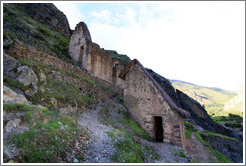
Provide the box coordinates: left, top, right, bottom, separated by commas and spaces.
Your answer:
124, 64, 184, 146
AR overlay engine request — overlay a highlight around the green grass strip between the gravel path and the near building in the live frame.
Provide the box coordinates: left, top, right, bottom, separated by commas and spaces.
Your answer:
99, 107, 158, 163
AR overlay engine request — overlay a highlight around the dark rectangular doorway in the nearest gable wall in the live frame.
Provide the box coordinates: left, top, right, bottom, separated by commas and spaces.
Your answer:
154, 116, 163, 142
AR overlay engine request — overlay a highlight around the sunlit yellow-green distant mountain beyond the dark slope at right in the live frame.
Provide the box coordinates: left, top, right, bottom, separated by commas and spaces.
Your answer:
170, 80, 243, 115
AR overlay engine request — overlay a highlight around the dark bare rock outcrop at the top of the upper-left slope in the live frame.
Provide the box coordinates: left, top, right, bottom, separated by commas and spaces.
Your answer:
19, 3, 71, 36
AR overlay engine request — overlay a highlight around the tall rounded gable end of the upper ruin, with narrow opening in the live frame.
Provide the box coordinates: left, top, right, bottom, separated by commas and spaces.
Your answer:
69, 22, 92, 70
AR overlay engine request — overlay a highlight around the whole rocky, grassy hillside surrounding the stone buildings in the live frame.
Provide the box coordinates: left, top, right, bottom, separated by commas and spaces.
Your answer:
2, 3, 243, 163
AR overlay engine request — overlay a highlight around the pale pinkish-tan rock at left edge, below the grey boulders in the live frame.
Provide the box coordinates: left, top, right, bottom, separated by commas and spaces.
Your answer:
3, 85, 28, 104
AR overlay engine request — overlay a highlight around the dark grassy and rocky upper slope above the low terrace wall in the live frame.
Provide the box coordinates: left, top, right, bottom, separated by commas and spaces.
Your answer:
3, 3, 72, 63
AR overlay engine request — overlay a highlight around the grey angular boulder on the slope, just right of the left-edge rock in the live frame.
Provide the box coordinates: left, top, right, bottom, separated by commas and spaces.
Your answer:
16, 66, 38, 86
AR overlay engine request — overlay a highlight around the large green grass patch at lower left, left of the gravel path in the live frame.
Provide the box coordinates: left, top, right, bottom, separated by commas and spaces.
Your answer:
8, 107, 83, 163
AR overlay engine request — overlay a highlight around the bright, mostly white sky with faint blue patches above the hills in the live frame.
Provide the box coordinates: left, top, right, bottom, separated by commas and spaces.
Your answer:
54, 1, 245, 90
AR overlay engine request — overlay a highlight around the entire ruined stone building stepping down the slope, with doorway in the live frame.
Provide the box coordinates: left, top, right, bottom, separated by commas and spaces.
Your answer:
69, 23, 189, 148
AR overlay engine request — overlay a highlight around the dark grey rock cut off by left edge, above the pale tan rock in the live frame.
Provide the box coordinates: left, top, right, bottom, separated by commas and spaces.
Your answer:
3, 52, 19, 79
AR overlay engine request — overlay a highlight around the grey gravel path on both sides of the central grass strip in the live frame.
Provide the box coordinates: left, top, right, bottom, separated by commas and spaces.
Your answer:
78, 106, 190, 163
